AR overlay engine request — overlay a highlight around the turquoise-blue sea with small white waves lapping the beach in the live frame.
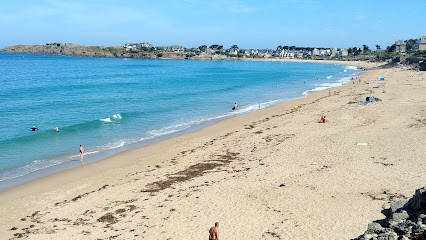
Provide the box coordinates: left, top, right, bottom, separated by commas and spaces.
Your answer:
0, 54, 359, 184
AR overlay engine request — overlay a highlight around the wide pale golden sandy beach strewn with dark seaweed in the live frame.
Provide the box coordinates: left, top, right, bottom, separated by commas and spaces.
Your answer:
0, 62, 426, 239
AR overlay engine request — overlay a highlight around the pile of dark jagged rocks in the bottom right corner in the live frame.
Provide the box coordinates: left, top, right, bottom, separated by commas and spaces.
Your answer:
355, 187, 426, 240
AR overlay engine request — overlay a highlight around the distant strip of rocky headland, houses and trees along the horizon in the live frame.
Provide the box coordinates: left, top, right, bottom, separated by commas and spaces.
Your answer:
1, 36, 426, 69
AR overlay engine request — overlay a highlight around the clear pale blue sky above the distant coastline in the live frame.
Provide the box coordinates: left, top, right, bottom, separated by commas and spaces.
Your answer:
0, 0, 426, 49
